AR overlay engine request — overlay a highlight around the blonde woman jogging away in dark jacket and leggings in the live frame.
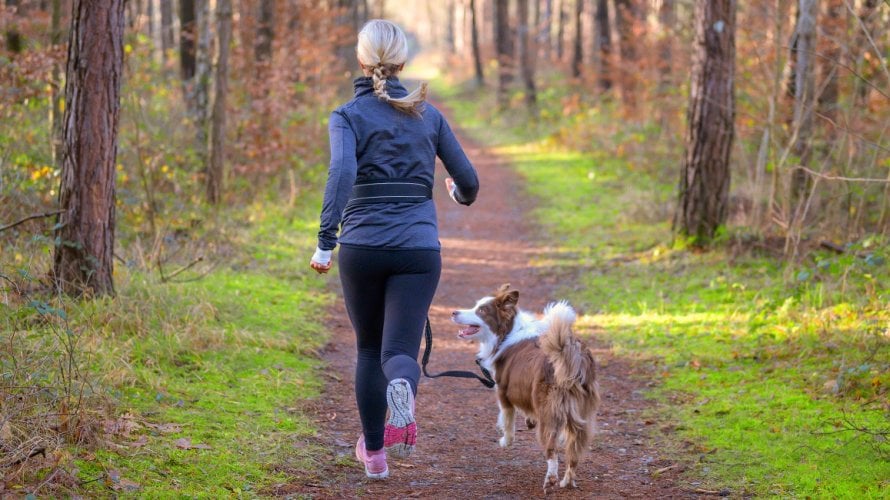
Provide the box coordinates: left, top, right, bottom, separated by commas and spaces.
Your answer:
310, 19, 479, 479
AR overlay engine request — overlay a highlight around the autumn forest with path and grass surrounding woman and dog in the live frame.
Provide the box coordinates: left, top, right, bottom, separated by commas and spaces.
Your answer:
0, 0, 890, 498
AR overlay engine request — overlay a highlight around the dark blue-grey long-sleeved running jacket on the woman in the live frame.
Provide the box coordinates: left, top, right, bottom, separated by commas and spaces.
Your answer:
318, 77, 479, 250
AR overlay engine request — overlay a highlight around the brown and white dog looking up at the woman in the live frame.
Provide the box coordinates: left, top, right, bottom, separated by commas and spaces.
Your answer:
451, 285, 599, 490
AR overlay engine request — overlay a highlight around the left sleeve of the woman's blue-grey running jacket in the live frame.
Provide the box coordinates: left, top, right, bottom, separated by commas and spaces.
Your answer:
318, 111, 358, 250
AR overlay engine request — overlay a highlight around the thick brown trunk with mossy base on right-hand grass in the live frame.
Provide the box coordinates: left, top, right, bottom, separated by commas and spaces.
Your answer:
674, 0, 736, 247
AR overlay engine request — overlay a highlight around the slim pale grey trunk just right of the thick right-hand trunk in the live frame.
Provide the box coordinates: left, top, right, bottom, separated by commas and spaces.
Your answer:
788, 0, 818, 221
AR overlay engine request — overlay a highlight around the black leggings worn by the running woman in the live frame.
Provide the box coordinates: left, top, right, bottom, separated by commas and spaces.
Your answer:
340, 246, 442, 451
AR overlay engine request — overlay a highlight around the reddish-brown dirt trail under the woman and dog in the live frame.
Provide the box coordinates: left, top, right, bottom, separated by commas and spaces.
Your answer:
272, 116, 695, 498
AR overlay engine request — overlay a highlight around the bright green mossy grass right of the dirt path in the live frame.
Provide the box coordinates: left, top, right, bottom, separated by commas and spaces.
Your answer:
440, 78, 890, 498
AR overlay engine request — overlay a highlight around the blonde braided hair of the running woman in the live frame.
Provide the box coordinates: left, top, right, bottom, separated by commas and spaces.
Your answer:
355, 19, 427, 116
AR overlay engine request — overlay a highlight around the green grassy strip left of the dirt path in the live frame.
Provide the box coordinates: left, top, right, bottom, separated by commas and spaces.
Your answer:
0, 195, 333, 498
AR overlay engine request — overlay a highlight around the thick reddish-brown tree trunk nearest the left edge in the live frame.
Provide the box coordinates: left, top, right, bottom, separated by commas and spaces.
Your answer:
53, 0, 125, 295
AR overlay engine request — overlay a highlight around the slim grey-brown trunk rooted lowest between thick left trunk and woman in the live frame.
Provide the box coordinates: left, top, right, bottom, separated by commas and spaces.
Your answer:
207, 0, 232, 205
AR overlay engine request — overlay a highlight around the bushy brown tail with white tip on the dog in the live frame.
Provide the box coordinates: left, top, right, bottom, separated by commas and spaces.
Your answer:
541, 301, 599, 434
